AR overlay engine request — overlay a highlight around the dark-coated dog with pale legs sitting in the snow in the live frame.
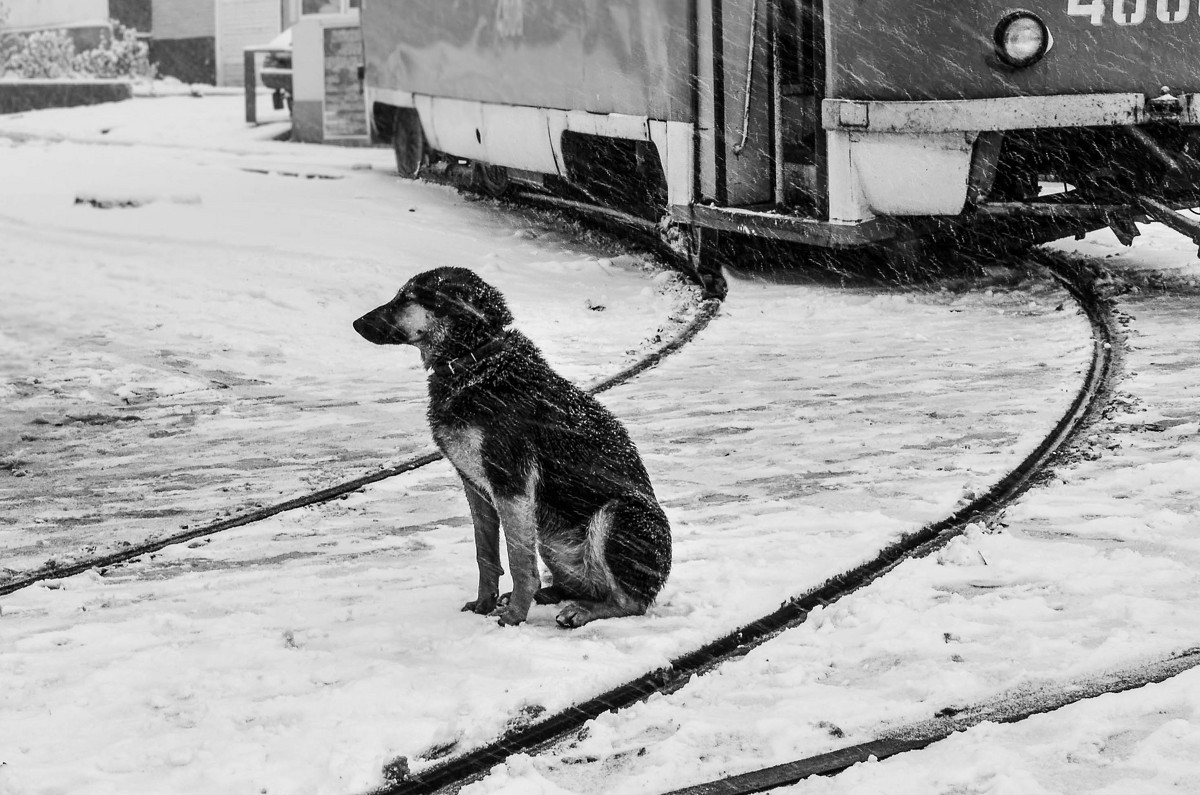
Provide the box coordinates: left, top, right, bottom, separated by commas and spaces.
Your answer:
354, 267, 671, 628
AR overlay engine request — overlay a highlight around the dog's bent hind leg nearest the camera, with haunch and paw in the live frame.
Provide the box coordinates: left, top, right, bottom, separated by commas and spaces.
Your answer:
557, 496, 671, 628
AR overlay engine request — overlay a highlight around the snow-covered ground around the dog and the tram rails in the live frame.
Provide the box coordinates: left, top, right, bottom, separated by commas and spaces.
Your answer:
0, 90, 1200, 795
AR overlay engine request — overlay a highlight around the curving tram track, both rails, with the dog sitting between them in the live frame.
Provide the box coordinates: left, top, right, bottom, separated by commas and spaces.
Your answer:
0, 164, 1116, 795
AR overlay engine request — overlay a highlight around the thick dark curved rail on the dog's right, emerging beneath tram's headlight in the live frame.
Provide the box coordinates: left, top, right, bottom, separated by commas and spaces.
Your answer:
370, 250, 1118, 795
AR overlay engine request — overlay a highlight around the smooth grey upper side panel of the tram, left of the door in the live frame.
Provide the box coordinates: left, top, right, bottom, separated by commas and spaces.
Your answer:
362, 0, 692, 121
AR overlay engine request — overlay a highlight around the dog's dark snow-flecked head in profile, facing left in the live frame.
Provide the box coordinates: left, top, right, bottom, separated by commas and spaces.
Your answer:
354, 268, 512, 358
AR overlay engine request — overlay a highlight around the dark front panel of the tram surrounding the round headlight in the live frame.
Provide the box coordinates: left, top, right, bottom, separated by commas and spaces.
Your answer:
826, 0, 1200, 101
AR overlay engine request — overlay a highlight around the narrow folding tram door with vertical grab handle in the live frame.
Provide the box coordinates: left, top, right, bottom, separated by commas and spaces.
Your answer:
697, 0, 824, 214
